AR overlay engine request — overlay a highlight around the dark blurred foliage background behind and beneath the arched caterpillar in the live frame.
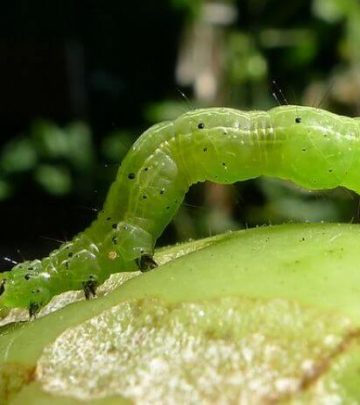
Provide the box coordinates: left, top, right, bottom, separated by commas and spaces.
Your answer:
0, 0, 360, 269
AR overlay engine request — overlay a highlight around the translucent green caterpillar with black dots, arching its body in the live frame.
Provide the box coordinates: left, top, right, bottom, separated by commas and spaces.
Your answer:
0, 106, 360, 316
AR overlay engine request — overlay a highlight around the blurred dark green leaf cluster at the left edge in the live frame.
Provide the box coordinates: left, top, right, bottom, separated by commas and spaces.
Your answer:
0, 120, 95, 199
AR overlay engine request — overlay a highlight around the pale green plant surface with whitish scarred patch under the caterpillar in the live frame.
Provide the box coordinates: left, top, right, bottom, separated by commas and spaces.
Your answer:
0, 224, 360, 404
